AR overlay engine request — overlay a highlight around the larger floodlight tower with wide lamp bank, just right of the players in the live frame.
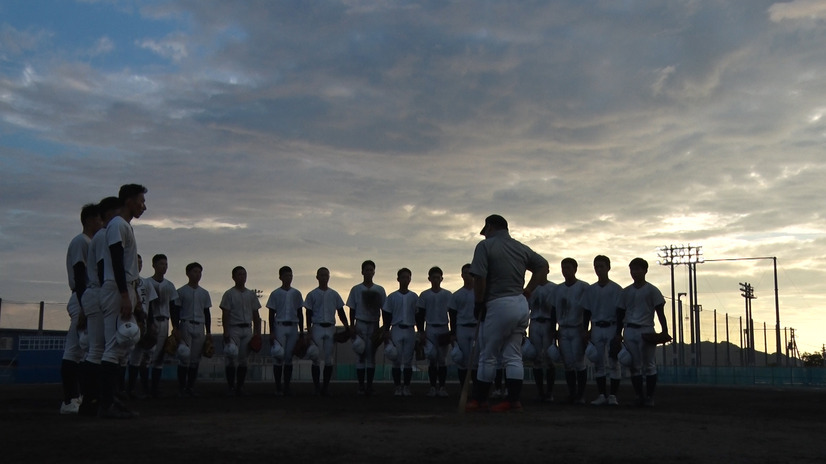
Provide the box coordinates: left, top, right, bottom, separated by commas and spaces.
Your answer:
657, 243, 705, 365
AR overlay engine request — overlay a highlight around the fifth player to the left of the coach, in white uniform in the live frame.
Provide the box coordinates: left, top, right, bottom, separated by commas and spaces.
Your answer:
304, 267, 350, 396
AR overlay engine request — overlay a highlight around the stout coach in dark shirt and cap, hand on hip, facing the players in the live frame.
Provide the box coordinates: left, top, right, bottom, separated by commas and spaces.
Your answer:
466, 214, 548, 412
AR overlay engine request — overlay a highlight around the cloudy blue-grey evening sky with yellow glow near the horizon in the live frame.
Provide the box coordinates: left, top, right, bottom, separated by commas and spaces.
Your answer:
0, 0, 826, 351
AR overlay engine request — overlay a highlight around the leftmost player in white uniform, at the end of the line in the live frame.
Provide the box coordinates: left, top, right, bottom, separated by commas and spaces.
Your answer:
60, 203, 103, 414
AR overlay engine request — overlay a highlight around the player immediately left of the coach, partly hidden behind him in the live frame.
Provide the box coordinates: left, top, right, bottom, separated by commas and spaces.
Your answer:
447, 263, 479, 389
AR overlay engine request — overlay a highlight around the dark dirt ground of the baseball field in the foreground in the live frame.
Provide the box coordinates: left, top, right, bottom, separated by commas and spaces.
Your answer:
0, 382, 826, 464
